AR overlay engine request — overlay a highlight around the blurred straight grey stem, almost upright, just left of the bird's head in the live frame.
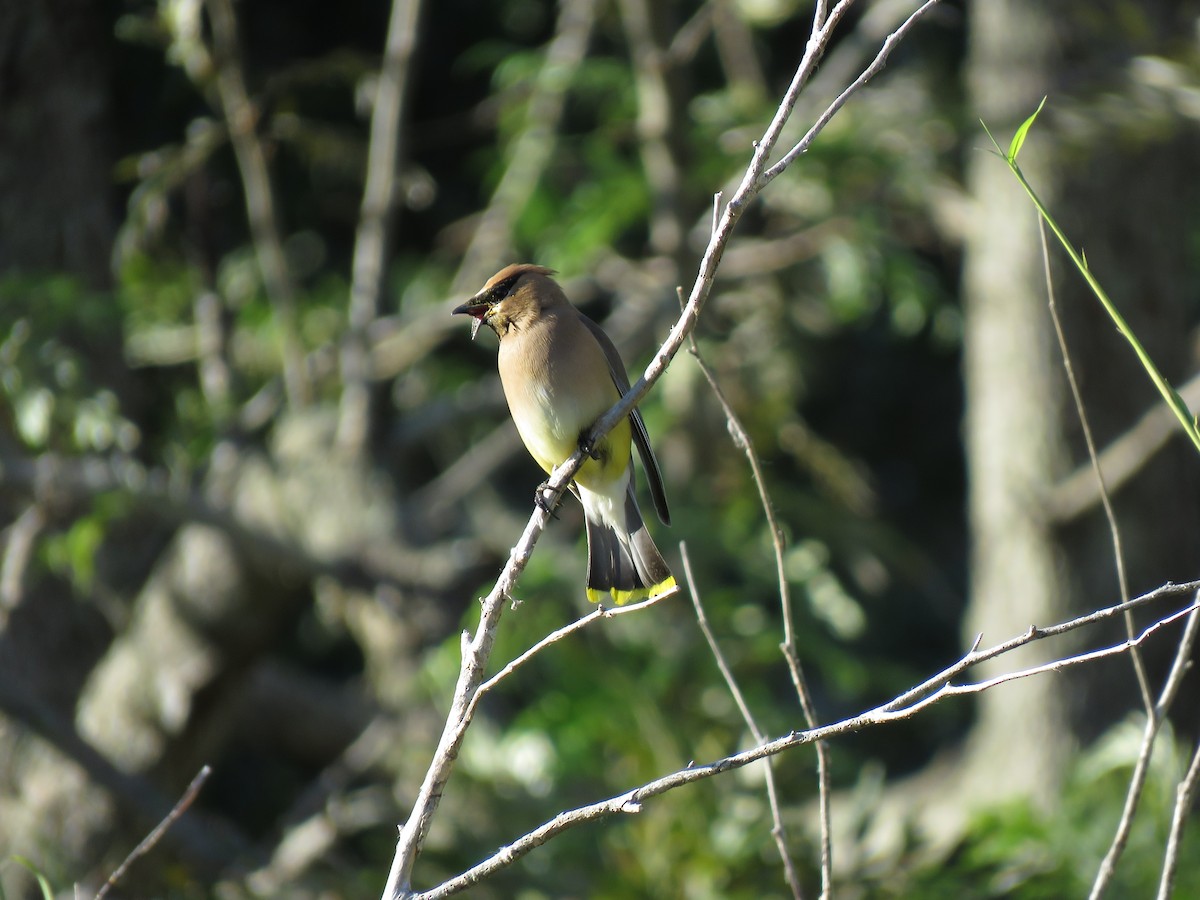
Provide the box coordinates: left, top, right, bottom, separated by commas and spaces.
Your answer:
337, 0, 421, 454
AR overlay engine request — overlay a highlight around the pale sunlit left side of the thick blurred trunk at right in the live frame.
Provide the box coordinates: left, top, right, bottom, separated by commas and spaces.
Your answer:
961, 0, 1072, 804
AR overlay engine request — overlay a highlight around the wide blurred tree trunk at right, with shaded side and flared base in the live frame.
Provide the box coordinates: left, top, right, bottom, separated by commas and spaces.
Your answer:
844, 0, 1200, 864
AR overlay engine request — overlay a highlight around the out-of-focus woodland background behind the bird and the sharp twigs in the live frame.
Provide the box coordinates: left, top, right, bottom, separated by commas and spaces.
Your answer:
0, 0, 1200, 900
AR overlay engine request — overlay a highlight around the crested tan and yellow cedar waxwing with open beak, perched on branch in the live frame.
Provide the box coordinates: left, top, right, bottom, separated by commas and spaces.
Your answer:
454, 263, 676, 606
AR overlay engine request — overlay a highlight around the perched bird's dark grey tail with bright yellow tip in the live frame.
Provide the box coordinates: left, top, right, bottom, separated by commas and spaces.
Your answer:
586, 487, 676, 606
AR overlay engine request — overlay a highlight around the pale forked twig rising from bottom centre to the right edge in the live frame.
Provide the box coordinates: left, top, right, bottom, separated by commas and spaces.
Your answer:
410, 582, 1200, 900
